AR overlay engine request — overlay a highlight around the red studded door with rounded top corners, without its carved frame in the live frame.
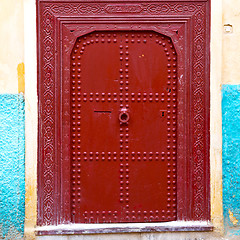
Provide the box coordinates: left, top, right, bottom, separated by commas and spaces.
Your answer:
70, 31, 177, 223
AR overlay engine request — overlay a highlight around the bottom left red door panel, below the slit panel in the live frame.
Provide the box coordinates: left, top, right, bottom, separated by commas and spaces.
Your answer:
77, 160, 119, 215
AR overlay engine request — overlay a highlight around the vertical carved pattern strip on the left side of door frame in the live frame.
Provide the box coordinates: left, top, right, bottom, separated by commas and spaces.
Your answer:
38, 9, 55, 225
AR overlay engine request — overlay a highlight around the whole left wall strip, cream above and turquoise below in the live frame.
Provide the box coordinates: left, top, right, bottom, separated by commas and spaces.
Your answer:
0, 0, 25, 239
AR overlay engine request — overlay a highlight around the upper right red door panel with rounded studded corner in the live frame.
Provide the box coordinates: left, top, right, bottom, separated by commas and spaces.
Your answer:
124, 32, 173, 94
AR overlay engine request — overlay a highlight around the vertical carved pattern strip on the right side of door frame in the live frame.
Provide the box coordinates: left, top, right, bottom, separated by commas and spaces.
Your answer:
192, 6, 207, 220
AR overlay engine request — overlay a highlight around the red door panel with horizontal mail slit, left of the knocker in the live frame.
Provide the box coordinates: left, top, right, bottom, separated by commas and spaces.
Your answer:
78, 102, 119, 155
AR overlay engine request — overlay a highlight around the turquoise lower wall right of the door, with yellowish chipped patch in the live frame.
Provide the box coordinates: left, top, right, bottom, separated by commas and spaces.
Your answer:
222, 85, 240, 234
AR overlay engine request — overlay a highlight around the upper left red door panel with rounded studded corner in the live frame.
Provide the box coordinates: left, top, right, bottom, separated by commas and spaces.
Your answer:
79, 33, 121, 93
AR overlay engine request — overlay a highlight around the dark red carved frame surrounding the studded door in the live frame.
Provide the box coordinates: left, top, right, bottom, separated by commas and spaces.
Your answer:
37, 0, 210, 230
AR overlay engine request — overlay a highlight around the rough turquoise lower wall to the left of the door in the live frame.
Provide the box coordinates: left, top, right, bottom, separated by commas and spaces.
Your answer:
0, 94, 25, 239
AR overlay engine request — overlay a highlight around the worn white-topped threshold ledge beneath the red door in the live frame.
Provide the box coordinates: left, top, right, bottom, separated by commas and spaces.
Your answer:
36, 221, 213, 236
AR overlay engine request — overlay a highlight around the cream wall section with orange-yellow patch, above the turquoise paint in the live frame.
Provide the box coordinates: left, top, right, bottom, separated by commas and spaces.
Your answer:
0, 0, 24, 93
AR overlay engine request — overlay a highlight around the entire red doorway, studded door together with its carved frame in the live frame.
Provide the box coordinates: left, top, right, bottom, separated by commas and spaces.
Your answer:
37, 0, 211, 229
